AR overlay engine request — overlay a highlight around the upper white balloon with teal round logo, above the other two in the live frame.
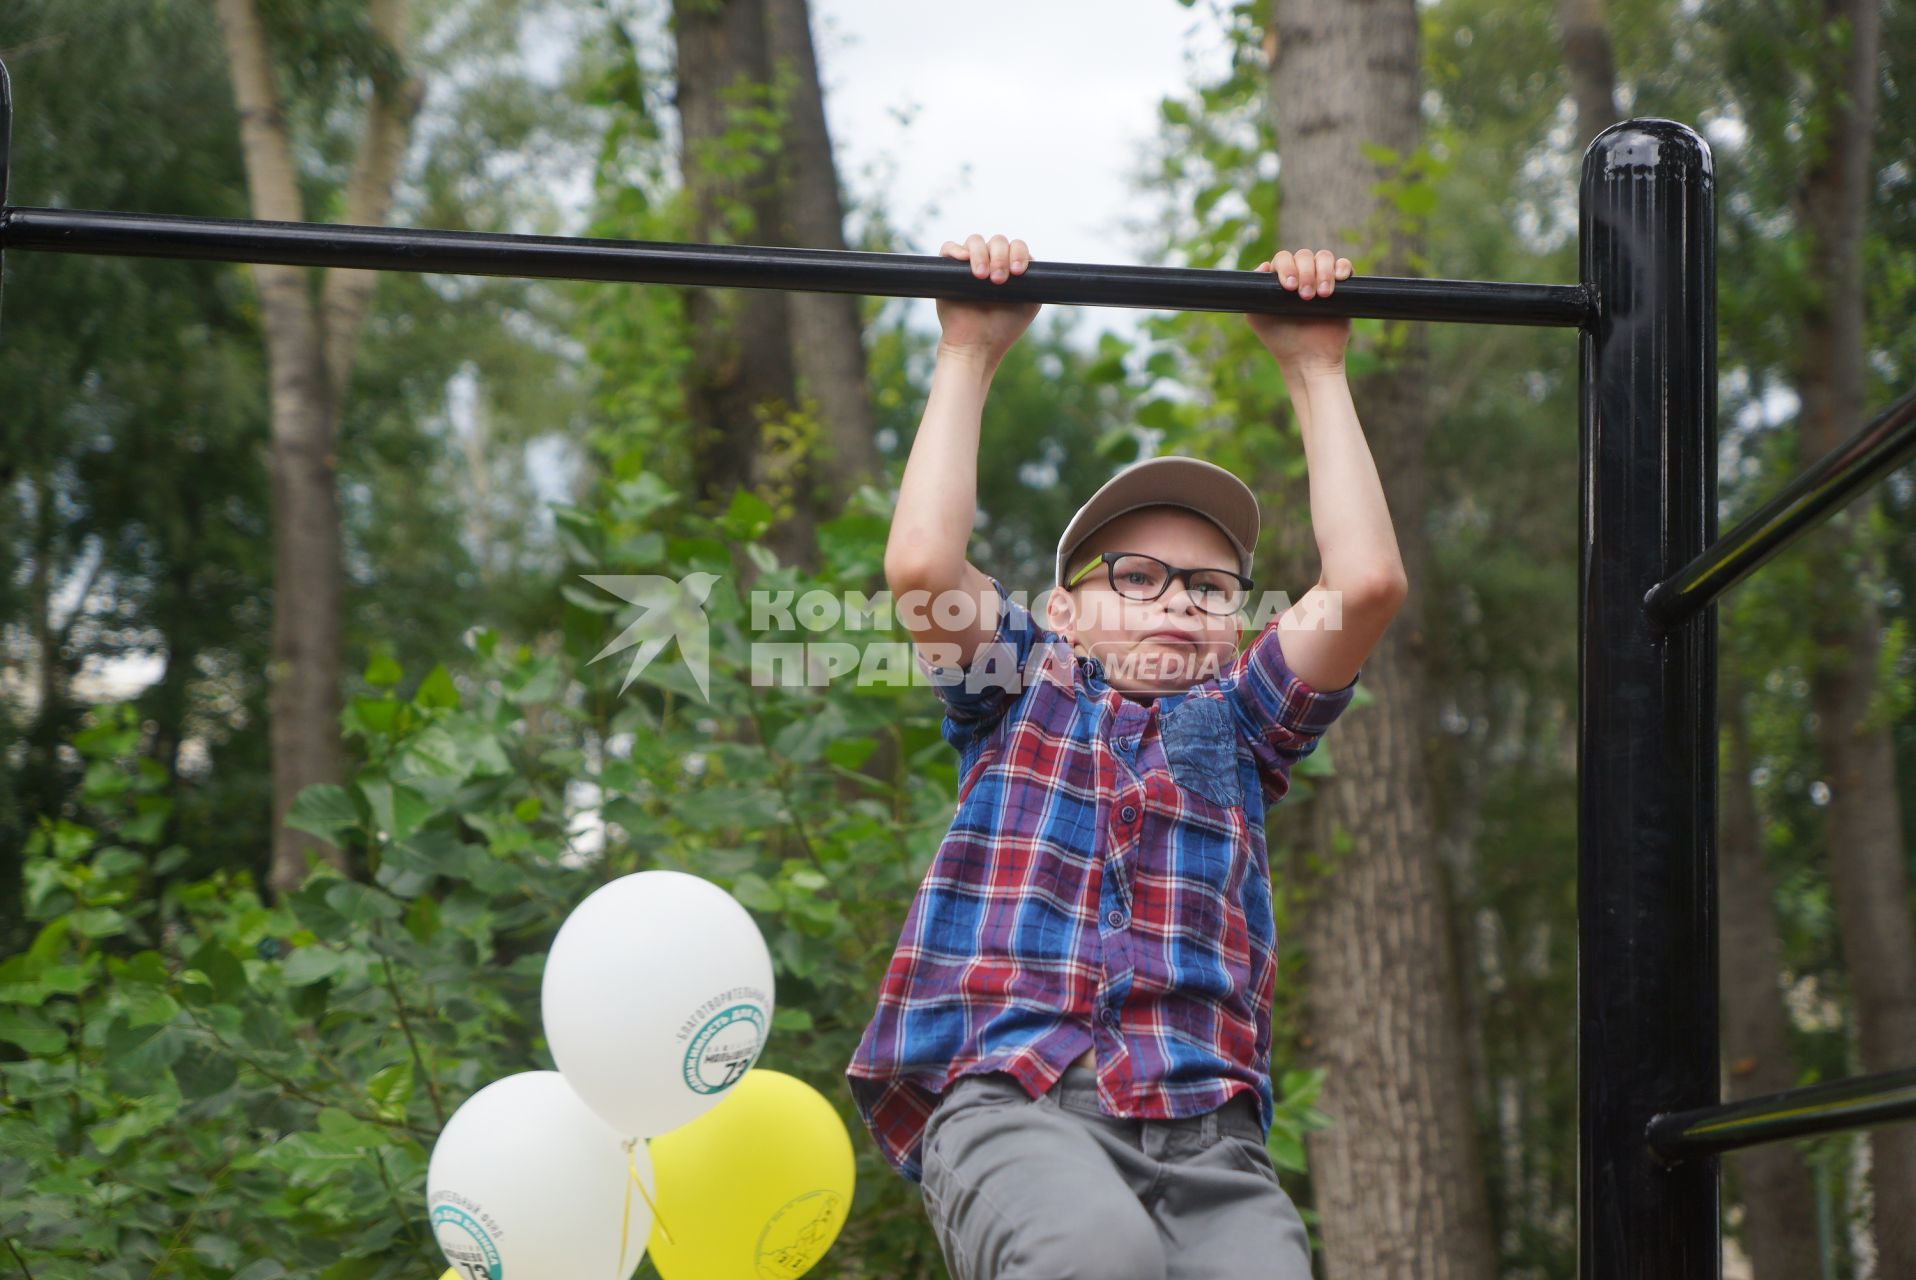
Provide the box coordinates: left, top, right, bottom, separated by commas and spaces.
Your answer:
540, 870, 772, 1138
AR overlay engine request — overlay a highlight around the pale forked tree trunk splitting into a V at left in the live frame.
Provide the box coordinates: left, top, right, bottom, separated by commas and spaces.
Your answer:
218, 0, 420, 893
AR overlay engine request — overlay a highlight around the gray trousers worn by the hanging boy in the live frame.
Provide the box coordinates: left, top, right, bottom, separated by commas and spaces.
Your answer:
920, 1065, 1311, 1280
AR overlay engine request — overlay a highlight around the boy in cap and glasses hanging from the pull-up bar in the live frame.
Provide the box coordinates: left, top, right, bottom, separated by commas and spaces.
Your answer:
847, 236, 1406, 1280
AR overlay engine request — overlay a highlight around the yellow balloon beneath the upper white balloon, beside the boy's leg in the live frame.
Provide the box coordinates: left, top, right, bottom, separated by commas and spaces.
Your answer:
646, 1069, 855, 1280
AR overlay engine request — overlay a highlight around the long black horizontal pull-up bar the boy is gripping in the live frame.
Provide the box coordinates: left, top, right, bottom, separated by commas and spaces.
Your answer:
0, 209, 1590, 328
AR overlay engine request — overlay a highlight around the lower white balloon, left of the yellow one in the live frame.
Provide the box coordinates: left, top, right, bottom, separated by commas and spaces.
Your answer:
425, 1071, 657, 1280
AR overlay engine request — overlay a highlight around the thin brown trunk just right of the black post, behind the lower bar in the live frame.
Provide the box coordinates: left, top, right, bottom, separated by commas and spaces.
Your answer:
1717, 673, 1822, 1280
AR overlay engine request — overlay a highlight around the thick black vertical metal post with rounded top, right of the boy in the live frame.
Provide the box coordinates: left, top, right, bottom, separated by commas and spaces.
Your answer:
1577, 119, 1721, 1280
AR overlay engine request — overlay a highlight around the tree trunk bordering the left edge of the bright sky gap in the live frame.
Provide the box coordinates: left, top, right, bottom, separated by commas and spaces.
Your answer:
764, 0, 878, 505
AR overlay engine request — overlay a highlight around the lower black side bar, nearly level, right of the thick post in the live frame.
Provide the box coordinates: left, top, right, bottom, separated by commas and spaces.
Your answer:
1640, 1057, 1916, 1161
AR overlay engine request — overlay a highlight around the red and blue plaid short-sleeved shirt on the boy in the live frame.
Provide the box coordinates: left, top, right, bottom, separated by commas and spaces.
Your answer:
845, 579, 1357, 1182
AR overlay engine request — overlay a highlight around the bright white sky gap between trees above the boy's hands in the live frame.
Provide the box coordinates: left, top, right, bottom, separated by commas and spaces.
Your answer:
812, 0, 1226, 341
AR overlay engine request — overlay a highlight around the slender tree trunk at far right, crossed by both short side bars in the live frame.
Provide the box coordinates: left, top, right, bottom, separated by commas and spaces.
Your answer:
1797, 0, 1916, 1276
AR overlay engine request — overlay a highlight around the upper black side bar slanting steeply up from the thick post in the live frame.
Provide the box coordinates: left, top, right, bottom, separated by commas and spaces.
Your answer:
1640, 383, 1916, 627
